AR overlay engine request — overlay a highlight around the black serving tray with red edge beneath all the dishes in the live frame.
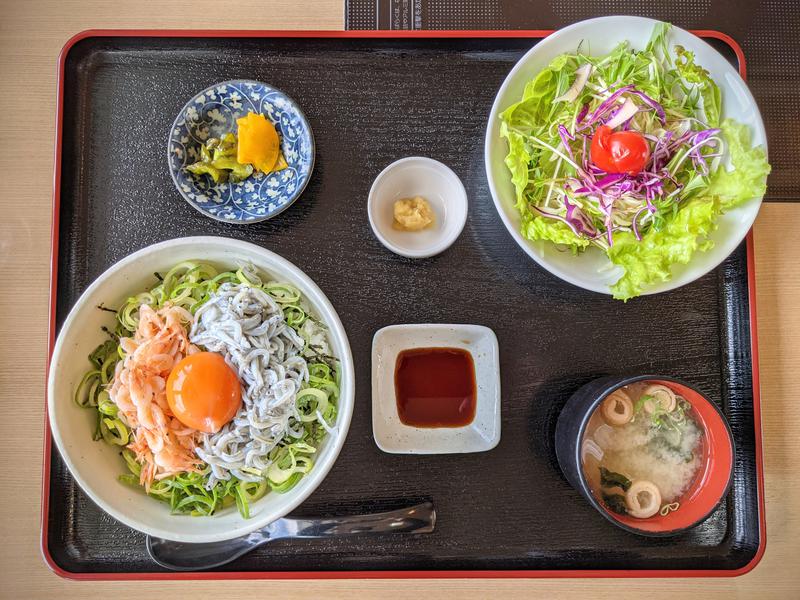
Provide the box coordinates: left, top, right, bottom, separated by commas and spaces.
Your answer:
42, 31, 764, 579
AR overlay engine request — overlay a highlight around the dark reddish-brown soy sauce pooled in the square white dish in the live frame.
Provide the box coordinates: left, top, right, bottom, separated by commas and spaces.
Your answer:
394, 348, 476, 427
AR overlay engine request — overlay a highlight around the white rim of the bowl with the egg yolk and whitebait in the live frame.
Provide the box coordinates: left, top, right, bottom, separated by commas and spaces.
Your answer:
47, 236, 355, 543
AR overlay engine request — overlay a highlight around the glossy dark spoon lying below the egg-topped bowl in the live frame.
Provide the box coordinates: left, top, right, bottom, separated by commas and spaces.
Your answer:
147, 502, 436, 571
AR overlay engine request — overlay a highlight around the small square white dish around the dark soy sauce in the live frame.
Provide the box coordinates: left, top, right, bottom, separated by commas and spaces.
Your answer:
372, 323, 500, 454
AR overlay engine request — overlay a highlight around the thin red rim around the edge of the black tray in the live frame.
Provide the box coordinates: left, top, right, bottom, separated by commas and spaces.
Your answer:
40, 29, 767, 581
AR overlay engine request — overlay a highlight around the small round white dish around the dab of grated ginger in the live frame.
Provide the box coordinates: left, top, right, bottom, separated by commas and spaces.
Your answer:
367, 156, 467, 258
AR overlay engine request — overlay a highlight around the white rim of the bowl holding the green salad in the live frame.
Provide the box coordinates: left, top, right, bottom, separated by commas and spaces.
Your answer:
484, 16, 767, 295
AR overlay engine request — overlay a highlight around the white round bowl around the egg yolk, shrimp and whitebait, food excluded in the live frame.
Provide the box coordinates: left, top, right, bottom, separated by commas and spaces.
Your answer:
47, 237, 355, 542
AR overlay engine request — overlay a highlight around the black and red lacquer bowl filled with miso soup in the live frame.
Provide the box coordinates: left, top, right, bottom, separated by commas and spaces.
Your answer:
555, 375, 734, 537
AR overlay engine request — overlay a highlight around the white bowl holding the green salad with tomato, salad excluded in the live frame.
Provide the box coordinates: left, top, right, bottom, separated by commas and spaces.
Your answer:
484, 16, 767, 294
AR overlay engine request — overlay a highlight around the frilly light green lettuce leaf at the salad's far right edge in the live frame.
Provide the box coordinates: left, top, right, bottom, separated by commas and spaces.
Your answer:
706, 119, 770, 210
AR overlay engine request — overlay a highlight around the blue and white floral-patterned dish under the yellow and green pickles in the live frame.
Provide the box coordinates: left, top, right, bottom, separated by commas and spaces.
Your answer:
167, 80, 314, 223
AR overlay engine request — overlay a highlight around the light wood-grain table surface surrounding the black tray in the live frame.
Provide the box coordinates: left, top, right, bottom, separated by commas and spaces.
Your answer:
0, 0, 800, 600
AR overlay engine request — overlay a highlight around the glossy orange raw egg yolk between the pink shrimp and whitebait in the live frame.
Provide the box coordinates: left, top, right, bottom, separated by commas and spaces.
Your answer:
167, 352, 242, 433
